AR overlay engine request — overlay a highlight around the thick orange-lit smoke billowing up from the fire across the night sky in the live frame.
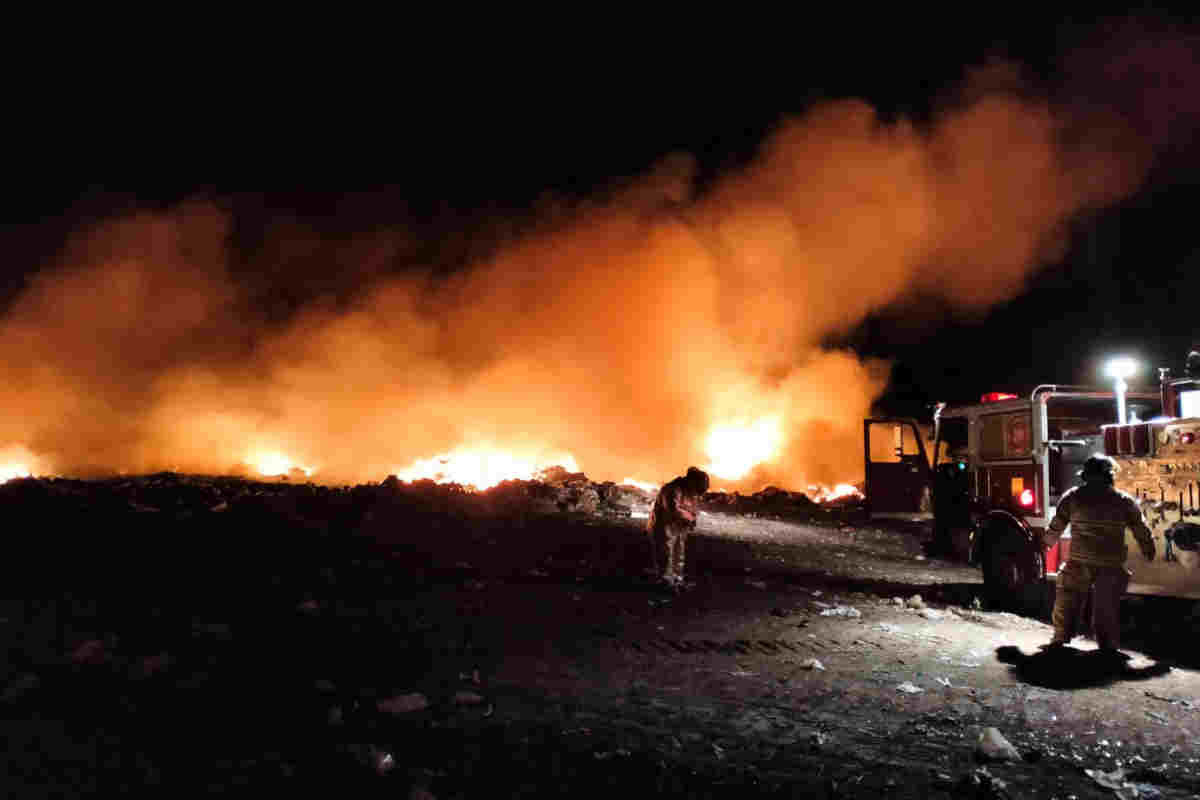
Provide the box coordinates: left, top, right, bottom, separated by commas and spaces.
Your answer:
0, 67, 1142, 488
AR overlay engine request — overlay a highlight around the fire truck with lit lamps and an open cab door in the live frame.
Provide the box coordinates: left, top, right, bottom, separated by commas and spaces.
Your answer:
864, 353, 1200, 614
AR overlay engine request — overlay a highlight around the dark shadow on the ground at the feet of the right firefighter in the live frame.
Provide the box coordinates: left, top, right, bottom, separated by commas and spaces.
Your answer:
996, 645, 1171, 690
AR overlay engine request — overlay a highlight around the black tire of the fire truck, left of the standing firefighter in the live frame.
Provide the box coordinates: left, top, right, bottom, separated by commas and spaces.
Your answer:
980, 519, 1048, 616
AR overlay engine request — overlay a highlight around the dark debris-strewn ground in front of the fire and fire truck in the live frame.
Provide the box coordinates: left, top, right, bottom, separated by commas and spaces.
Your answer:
0, 475, 1200, 798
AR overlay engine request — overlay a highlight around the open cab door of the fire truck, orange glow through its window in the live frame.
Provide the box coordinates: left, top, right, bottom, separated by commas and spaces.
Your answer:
863, 417, 932, 517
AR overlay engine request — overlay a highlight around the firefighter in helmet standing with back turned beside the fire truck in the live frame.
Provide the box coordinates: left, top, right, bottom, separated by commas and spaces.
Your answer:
1046, 455, 1154, 656
